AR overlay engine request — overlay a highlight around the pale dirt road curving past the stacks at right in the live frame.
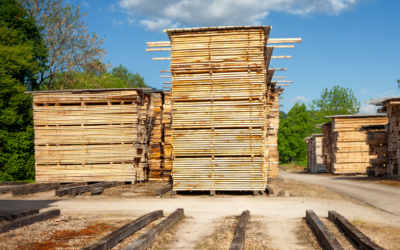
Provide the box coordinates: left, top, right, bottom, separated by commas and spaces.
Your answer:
279, 172, 400, 215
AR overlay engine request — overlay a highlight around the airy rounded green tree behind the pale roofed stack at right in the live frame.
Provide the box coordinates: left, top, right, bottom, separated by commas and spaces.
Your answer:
309, 86, 361, 127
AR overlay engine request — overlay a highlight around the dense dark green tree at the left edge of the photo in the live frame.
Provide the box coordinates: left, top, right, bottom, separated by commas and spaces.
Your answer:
0, 0, 46, 181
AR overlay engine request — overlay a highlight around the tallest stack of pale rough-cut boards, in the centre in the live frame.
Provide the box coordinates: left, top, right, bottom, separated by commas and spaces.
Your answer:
169, 27, 272, 191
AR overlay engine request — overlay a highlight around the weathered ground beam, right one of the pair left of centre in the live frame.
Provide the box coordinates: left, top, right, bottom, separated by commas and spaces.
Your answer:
125, 208, 184, 250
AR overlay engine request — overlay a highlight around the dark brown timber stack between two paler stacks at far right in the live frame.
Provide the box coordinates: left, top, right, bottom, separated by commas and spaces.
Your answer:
360, 125, 389, 176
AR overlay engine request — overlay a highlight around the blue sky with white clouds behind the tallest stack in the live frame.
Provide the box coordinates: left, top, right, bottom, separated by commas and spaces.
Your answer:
66, 0, 400, 113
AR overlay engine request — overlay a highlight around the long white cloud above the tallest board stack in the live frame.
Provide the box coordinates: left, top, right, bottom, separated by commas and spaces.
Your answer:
119, 0, 366, 30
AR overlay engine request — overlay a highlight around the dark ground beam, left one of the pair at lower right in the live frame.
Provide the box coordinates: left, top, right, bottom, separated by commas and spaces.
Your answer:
306, 210, 344, 250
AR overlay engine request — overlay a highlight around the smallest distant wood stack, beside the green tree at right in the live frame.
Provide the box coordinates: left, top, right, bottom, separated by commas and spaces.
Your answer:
304, 134, 326, 173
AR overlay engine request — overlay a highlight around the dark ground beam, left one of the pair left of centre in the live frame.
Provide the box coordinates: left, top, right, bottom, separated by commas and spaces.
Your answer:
82, 210, 163, 250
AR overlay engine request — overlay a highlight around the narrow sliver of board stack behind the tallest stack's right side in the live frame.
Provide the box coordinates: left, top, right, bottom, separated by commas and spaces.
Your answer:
267, 92, 279, 179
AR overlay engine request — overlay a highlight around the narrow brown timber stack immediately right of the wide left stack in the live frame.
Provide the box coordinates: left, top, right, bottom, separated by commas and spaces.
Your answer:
148, 93, 163, 180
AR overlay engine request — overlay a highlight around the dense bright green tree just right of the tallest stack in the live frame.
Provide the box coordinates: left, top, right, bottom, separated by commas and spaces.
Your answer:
278, 103, 311, 163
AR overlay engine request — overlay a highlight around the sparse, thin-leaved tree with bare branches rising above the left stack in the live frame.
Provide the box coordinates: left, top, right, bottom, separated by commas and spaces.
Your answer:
18, 0, 111, 89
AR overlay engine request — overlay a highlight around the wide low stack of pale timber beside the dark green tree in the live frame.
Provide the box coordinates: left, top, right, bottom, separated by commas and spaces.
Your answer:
28, 89, 150, 182
